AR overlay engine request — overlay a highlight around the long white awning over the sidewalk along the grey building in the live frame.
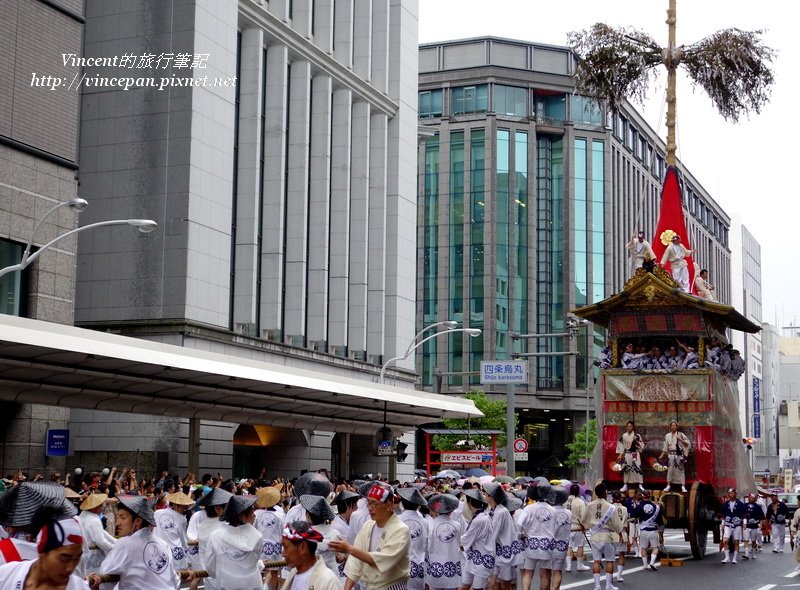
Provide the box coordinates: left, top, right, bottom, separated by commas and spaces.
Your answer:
0, 315, 482, 434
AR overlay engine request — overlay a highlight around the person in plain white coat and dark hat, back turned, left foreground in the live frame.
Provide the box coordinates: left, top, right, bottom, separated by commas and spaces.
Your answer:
203, 495, 264, 590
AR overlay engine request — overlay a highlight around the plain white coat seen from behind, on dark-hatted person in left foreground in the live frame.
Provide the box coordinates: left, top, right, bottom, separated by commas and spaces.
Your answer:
203, 524, 264, 590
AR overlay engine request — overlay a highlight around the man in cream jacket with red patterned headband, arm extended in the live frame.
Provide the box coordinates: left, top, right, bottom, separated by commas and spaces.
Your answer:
330, 482, 410, 590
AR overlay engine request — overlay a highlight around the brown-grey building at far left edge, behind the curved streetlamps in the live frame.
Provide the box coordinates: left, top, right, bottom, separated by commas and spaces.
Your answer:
0, 0, 85, 477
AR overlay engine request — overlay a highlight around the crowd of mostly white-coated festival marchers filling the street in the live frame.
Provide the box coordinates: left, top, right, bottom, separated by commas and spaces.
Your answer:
0, 470, 800, 590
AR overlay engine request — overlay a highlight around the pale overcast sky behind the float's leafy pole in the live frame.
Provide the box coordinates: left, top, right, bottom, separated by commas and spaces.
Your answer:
419, 0, 800, 327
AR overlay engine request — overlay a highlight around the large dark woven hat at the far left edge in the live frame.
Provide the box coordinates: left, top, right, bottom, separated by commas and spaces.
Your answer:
0, 480, 78, 527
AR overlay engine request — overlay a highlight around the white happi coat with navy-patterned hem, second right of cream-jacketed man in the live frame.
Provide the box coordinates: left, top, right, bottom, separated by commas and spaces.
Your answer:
425, 514, 464, 588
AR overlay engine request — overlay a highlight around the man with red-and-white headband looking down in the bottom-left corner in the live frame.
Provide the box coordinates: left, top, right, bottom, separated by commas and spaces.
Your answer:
0, 509, 88, 590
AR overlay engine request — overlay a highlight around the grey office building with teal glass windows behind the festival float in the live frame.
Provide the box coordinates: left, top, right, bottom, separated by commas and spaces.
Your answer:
417, 37, 731, 471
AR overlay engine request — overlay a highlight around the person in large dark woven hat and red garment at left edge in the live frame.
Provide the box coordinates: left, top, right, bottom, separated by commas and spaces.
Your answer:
0, 480, 78, 564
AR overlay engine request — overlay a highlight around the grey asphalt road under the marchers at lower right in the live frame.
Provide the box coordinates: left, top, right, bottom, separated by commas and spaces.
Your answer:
560, 529, 800, 590
